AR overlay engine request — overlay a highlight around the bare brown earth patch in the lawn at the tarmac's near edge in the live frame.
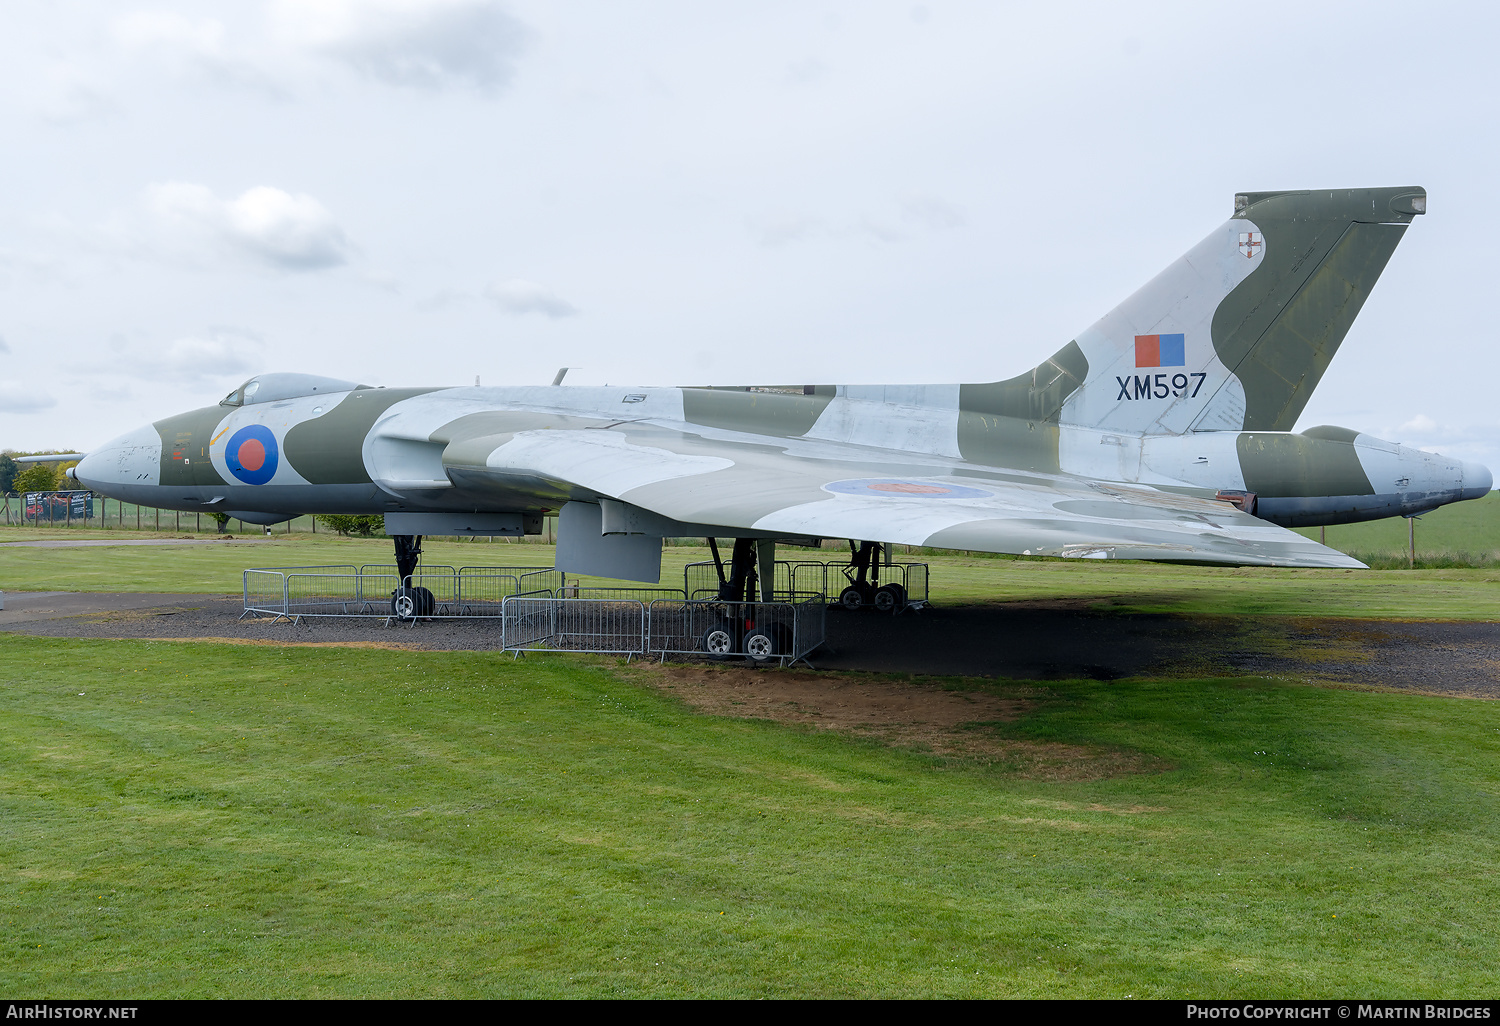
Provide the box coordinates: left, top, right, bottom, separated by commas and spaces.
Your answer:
626, 665, 1170, 780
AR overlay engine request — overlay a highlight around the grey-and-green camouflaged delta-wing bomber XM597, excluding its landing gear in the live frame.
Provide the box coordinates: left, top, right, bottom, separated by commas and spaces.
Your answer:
75, 188, 1491, 581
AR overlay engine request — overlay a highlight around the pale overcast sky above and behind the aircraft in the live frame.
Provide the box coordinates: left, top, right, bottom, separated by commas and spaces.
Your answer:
0, 0, 1500, 467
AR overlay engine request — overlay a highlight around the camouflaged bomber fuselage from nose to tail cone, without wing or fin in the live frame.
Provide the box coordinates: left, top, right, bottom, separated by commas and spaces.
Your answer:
74, 375, 1491, 527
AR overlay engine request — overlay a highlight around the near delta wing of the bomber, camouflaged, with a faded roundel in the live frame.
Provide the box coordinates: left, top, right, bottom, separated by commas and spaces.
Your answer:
474, 422, 1364, 569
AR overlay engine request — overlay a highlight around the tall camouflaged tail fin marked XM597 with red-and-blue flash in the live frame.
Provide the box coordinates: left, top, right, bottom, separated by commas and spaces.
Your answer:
1026, 186, 1427, 435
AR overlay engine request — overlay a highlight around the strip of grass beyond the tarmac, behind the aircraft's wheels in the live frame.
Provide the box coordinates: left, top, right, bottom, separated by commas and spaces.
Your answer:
0, 528, 1500, 620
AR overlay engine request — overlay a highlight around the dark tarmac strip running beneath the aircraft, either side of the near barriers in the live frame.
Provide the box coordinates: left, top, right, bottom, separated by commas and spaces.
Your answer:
0, 593, 1500, 702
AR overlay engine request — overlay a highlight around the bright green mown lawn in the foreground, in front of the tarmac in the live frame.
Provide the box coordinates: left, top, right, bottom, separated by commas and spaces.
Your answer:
0, 635, 1500, 998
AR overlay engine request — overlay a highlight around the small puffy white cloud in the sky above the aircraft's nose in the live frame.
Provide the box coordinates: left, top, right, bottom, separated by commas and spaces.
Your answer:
146, 182, 350, 272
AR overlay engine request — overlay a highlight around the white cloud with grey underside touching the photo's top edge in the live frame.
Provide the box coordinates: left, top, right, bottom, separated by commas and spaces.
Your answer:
272, 0, 530, 92
